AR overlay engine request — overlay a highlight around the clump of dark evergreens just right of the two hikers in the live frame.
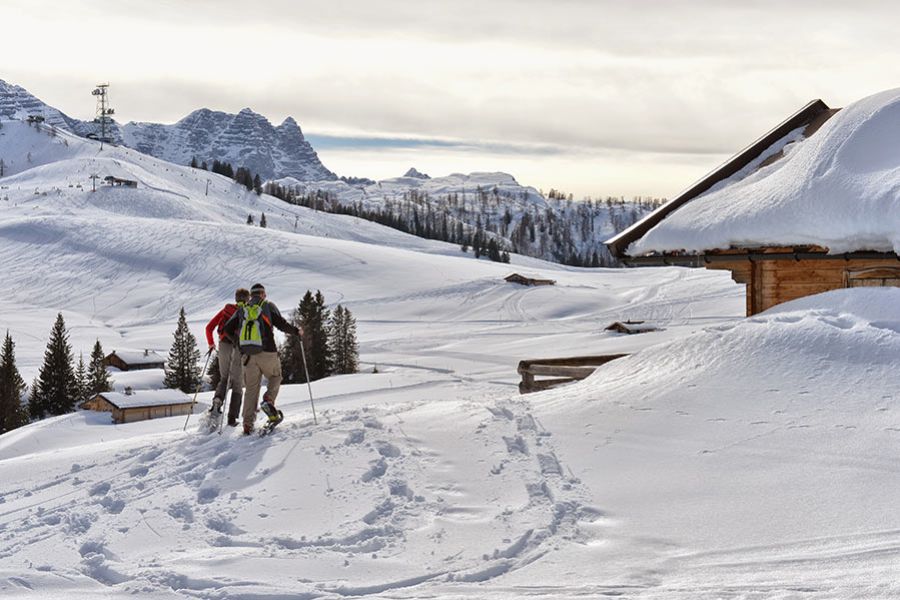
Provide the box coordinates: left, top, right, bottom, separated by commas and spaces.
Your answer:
278, 290, 359, 383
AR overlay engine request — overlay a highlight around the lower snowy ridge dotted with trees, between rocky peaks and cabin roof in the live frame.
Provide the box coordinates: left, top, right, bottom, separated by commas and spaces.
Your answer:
268, 169, 659, 267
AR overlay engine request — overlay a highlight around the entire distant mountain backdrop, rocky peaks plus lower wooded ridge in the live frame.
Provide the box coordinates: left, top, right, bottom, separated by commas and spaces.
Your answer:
0, 80, 661, 267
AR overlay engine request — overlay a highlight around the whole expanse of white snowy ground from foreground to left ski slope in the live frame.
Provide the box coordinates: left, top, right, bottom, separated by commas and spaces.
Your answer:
0, 121, 900, 600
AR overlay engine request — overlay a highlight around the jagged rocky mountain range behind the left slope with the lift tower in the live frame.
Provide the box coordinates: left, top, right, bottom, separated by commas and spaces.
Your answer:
0, 80, 337, 181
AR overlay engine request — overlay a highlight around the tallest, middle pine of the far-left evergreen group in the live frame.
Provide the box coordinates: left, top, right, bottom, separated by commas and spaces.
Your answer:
28, 313, 78, 419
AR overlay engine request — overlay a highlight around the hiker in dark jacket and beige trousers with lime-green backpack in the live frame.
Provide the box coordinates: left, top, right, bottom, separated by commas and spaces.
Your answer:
225, 283, 303, 435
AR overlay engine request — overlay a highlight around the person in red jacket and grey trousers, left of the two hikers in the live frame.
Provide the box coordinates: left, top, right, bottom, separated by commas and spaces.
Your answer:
206, 288, 250, 427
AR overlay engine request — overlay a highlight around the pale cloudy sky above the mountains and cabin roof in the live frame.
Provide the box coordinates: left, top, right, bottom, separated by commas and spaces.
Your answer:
0, 0, 900, 197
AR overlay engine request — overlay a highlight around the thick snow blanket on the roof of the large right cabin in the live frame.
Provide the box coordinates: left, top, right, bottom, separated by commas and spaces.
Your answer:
625, 89, 900, 256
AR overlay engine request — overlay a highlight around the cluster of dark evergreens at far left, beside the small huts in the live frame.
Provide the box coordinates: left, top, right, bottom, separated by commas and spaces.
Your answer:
0, 313, 112, 433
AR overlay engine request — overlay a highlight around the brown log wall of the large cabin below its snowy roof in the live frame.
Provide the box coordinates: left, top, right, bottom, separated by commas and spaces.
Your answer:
707, 258, 900, 316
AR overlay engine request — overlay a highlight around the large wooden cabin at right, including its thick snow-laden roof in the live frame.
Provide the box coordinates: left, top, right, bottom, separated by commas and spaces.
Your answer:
606, 90, 900, 316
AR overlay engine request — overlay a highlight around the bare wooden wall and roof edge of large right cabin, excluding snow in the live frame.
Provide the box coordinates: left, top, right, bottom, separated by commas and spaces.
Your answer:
606, 100, 900, 316
